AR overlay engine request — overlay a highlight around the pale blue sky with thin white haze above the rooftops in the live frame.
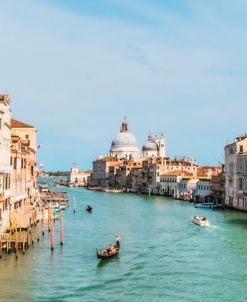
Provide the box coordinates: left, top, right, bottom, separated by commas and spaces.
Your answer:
0, 0, 247, 171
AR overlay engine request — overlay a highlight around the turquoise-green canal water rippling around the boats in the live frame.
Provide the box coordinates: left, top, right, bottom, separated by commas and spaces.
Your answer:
0, 178, 247, 302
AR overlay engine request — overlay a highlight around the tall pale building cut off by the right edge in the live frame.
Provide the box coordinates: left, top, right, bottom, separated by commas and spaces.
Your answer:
225, 134, 247, 211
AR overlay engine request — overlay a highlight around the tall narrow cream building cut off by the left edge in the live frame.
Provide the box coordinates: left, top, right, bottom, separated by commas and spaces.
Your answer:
0, 94, 12, 233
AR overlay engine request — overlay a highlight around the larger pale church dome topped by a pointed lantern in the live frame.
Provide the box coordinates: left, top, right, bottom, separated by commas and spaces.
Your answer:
110, 117, 140, 161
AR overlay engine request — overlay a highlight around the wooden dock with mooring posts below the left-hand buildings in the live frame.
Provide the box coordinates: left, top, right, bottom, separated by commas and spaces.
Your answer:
0, 190, 68, 259
